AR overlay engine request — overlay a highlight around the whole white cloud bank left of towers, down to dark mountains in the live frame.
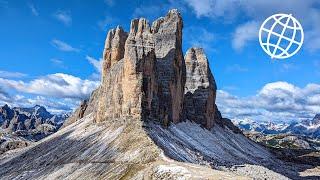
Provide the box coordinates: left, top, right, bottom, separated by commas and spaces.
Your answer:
0, 73, 100, 113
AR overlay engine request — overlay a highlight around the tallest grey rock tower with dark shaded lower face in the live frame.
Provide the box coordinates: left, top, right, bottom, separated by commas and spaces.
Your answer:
152, 9, 185, 123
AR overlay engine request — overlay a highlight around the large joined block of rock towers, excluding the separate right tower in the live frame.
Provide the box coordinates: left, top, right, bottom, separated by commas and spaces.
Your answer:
96, 10, 185, 124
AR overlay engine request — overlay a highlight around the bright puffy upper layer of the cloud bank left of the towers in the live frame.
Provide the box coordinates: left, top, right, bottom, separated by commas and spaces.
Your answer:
0, 73, 99, 99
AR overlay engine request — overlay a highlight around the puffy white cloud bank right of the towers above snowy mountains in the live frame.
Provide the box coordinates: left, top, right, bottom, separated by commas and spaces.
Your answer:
217, 81, 320, 121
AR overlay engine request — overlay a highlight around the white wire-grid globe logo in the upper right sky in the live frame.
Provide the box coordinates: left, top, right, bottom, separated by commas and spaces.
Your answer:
259, 14, 304, 59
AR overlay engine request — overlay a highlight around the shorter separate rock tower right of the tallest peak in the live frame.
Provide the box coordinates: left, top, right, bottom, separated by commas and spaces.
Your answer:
184, 48, 217, 129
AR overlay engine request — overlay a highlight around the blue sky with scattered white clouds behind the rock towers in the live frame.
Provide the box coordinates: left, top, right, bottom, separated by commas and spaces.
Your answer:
0, 0, 320, 121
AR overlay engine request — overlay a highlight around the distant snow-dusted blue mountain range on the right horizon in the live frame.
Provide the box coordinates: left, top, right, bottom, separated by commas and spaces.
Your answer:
233, 114, 320, 138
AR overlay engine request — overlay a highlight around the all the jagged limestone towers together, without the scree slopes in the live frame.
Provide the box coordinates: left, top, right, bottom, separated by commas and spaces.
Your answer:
89, 10, 236, 129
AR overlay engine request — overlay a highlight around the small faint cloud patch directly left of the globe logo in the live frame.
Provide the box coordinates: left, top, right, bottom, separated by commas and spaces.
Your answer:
232, 21, 260, 51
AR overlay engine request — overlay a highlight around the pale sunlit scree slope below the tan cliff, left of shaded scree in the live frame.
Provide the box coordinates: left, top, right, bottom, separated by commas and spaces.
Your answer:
0, 114, 250, 179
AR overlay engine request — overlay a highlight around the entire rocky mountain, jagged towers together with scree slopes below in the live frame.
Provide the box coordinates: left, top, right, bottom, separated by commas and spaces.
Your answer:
0, 10, 308, 179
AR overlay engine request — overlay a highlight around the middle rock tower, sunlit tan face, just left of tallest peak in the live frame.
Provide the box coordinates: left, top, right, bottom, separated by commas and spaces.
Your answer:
123, 18, 157, 121
